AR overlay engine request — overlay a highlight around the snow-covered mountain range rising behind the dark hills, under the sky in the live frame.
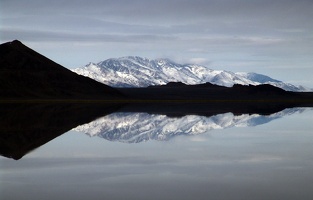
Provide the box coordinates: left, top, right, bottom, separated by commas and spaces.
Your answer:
73, 56, 306, 91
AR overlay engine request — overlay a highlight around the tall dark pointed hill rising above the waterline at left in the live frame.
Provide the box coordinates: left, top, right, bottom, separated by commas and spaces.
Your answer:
0, 40, 122, 100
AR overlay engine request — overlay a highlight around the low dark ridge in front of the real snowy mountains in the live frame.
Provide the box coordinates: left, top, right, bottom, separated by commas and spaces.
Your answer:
119, 82, 313, 104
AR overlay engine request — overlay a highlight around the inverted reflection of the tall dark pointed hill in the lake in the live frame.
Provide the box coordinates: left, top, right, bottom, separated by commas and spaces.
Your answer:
0, 103, 120, 160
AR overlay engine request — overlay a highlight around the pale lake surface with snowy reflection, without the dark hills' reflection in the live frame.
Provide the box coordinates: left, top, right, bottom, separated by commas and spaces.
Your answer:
0, 108, 313, 200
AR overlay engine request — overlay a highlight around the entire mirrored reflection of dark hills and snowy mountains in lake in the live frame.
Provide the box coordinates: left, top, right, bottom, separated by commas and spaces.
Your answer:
0, 103, 305, 160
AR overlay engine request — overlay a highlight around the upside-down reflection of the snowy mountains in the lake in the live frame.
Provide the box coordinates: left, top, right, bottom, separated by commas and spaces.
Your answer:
74, 108, 307, 143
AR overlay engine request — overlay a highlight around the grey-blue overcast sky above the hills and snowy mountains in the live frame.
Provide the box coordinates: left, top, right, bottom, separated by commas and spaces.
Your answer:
0, 0, 313, 88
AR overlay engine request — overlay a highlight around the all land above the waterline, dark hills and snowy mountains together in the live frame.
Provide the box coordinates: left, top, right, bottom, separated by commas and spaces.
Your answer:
0, 40, 313, 102
